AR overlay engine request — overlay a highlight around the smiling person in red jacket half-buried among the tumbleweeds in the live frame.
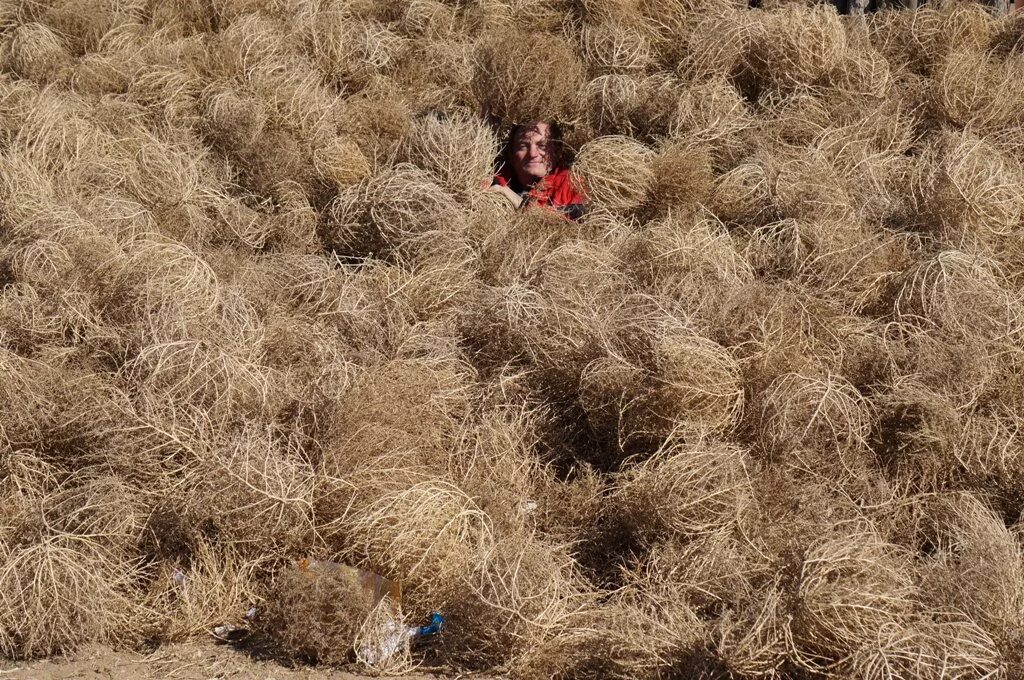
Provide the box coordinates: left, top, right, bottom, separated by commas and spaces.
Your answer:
490, 121, 585, 219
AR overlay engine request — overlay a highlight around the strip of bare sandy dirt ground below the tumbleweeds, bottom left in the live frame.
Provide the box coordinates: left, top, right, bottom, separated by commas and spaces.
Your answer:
0, 644, 494, 680
